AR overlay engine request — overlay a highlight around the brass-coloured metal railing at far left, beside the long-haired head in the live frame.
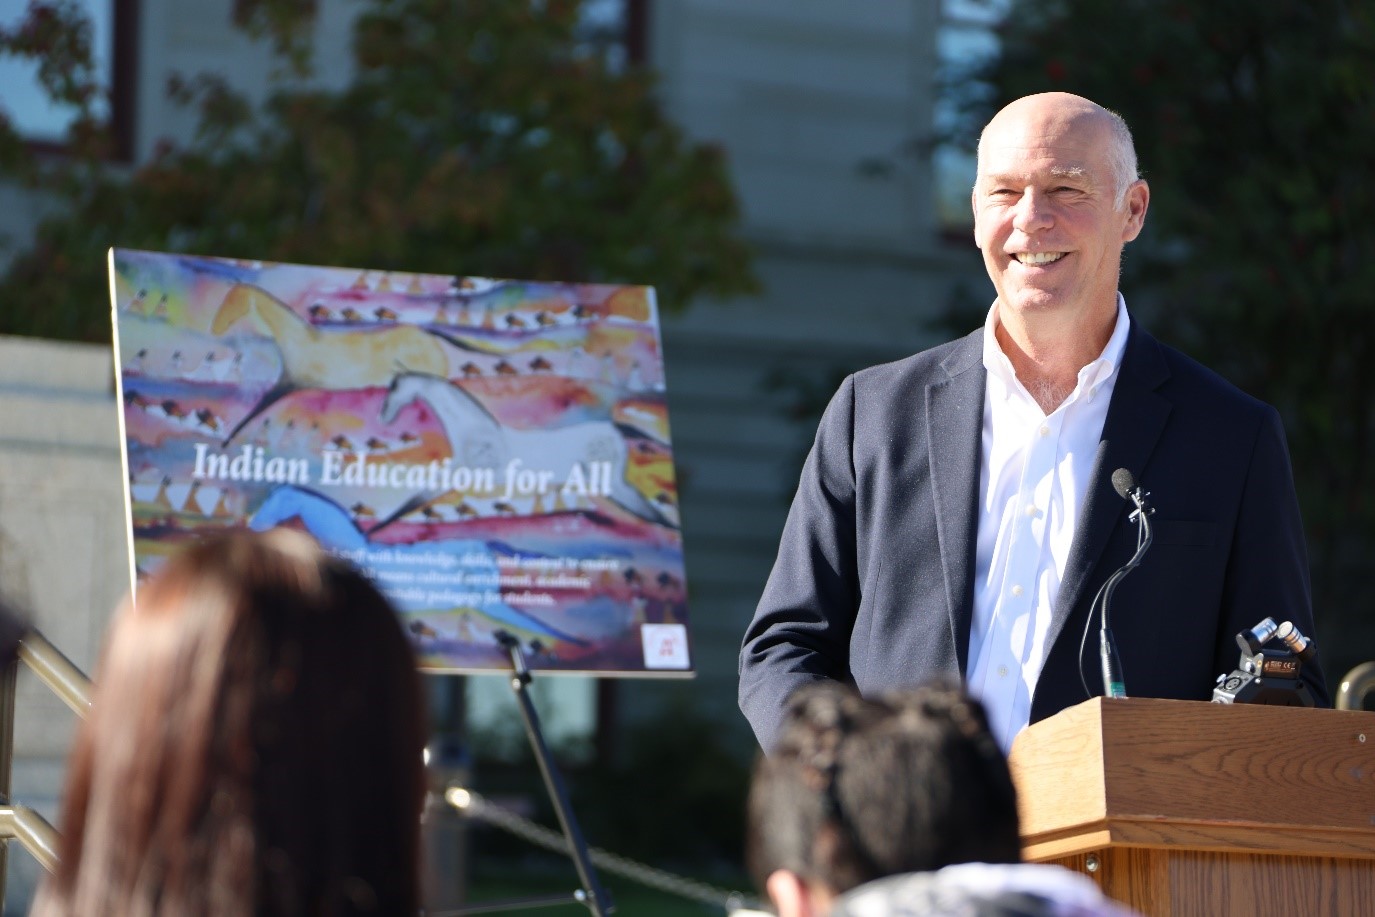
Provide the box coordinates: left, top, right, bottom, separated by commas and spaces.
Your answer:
0, 630, 91, 901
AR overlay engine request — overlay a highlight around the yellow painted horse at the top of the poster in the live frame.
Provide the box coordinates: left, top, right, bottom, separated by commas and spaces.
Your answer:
210, 283, 480, 444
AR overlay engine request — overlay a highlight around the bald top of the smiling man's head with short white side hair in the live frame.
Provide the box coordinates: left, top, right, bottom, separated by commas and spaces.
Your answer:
979, 92, 1141, 209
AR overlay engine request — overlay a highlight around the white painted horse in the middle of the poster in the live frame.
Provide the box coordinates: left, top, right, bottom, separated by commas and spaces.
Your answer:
381, 373, 672, 525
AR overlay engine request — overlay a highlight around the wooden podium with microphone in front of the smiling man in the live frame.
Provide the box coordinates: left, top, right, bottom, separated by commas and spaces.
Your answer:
1011, 697, 1375, 917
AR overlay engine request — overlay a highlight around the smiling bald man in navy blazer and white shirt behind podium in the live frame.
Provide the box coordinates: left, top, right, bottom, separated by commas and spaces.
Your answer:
740, 92, 1327, 749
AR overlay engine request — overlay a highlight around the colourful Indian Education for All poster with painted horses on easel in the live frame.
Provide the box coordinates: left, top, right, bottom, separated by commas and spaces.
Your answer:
110, 249, 692, 676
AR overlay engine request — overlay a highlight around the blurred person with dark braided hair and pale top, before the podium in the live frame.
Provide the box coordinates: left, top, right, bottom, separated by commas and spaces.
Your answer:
747, 682, 1132, 917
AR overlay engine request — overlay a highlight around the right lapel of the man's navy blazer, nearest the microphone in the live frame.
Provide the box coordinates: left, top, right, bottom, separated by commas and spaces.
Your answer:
1046, 323, 1170, 646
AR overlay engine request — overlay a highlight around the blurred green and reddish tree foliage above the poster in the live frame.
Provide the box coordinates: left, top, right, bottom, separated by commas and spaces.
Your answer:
0, 0, 755, 341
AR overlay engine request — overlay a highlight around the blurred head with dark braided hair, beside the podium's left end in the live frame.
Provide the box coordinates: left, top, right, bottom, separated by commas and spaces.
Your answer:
747, 682, 1022, 917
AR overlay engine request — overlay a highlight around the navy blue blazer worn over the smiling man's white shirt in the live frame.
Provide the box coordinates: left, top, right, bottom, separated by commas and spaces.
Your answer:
740, 322, 1330, 749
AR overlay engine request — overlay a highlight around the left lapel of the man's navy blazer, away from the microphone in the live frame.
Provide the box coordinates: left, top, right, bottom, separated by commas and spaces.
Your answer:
927, 329, 987, 676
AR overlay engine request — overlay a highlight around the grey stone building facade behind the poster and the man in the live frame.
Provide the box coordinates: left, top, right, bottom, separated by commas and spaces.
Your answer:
0, 0, 982, 901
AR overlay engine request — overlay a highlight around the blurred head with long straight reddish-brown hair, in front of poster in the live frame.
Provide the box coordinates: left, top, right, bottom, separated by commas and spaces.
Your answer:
36, 529, 425, 916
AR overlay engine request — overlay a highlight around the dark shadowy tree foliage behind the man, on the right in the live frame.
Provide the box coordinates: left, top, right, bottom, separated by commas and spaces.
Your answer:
969, 0, 1375, 687
